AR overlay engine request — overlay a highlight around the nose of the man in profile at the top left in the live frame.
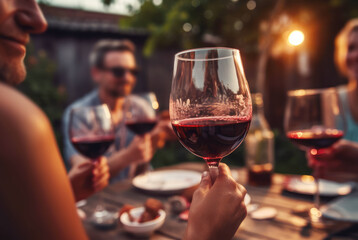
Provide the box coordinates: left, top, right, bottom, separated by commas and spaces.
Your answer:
15, 0, 47, 33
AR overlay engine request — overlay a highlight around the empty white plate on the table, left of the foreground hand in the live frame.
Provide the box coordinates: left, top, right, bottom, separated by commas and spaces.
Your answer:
132, 170, 201, 194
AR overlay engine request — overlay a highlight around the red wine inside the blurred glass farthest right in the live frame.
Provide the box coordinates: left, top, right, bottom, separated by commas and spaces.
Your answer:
287, 129, 344, 149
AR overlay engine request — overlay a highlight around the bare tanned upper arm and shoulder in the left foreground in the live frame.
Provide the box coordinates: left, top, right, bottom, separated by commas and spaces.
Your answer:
0, 84, 87, 240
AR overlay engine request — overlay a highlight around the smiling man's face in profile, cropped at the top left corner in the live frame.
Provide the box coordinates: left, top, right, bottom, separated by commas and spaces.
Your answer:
0, 0, 47, 85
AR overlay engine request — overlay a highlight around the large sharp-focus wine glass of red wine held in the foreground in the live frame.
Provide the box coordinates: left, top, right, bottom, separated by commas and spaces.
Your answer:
169, 48, 252, 181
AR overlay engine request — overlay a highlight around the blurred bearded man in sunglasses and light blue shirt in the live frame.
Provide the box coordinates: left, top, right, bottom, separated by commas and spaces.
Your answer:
62, 40, 174, 181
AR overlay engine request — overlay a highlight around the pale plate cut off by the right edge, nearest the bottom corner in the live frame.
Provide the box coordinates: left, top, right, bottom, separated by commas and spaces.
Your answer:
320, 192, 358, 222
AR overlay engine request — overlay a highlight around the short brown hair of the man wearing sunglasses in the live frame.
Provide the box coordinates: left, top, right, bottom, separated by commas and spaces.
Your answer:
90, 39, 135, 68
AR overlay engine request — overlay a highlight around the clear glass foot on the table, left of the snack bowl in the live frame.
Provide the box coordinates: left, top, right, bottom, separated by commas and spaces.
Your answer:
90, 209, 118, 229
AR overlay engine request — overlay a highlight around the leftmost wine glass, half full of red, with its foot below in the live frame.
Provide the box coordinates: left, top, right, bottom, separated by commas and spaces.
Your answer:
69, 104, 116, 226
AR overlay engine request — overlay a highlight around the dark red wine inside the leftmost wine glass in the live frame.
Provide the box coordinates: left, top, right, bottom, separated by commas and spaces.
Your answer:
71, 135, 114, 161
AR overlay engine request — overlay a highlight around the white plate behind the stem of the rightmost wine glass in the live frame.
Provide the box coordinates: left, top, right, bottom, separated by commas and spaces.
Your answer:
284, 175, 355, 197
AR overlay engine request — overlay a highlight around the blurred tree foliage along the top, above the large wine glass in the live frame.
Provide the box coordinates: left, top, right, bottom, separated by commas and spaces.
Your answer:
121, 0, 358, 55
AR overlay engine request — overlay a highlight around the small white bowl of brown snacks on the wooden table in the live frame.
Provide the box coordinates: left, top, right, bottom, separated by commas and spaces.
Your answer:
120, 199, 166, 237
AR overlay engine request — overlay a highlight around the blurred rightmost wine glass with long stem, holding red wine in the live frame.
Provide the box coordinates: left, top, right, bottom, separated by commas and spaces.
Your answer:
284, 88, 345, 226
